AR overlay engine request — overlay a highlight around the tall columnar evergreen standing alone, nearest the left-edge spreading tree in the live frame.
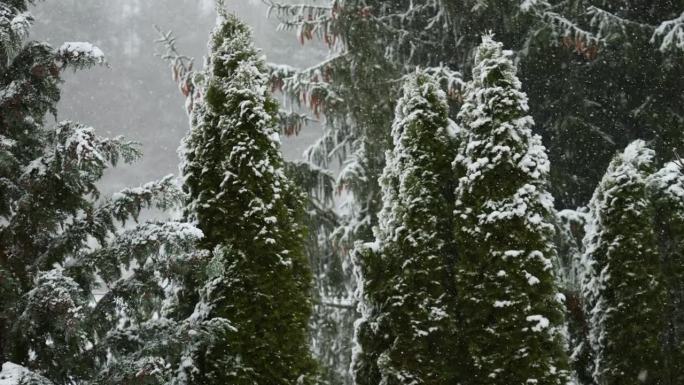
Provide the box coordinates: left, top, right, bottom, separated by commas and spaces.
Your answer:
182, 9, 316, 385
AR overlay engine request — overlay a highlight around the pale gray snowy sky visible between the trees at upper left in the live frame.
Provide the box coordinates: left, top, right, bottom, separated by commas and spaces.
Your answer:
31, 0, 327, 193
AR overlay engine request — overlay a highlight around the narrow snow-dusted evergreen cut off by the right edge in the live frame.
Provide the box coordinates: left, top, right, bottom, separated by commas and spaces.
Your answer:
649, 162, 684, 385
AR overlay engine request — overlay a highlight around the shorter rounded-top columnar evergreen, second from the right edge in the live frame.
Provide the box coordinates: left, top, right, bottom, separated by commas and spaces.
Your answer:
583, 140, 666, 385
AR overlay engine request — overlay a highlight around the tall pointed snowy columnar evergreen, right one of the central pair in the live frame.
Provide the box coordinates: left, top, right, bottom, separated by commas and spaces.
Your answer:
455, 36, 568, 385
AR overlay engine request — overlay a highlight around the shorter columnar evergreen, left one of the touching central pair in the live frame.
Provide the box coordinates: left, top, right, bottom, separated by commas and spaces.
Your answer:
352, 71, 458, 385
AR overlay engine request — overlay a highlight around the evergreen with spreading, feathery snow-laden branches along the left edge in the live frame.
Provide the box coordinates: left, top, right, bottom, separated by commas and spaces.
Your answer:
0, 1, 201, 384
